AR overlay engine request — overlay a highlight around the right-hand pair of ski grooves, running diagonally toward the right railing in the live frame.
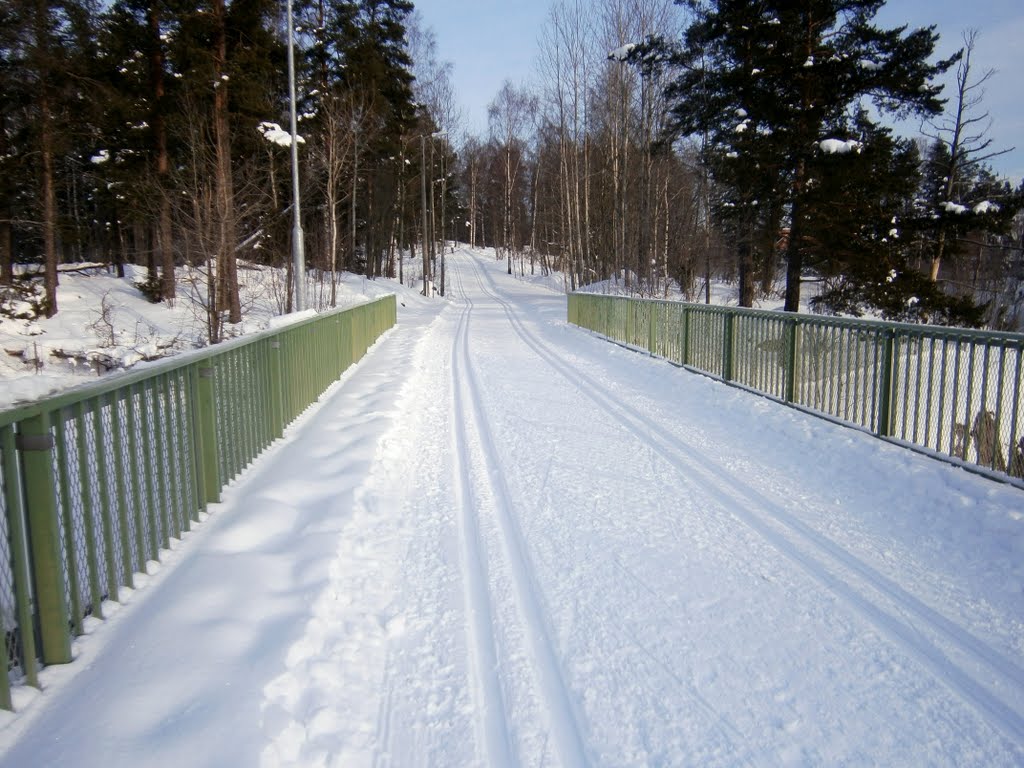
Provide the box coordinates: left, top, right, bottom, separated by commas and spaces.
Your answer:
460, 250, 1024, 743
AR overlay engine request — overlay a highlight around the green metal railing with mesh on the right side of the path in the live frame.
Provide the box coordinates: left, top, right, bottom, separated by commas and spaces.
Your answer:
568, 294, 1024, 486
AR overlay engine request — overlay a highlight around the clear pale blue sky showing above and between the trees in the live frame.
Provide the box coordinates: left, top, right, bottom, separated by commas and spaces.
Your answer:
416, 0, 1024, 180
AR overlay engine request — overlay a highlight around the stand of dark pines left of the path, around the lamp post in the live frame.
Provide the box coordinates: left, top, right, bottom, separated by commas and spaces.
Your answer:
0, 0, 462, 341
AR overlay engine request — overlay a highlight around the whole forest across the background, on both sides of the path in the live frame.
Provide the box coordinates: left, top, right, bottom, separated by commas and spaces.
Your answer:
0, 0, 1024, 343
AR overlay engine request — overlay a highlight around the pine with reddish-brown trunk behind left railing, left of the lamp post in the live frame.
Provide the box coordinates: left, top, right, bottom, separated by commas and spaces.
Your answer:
168, 0, 287, 331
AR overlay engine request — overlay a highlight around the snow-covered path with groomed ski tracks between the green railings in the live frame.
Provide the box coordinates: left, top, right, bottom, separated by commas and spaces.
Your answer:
0, 251, 1024, 768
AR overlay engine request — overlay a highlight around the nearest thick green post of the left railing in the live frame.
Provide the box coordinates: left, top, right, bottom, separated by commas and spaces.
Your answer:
16, 414, 71, 664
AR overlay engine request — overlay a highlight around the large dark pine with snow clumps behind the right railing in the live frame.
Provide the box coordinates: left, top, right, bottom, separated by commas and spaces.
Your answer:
670, 0, 954, 311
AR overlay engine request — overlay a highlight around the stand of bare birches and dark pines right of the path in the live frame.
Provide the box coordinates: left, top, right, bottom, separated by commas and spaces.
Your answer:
463, 0, 1024, 328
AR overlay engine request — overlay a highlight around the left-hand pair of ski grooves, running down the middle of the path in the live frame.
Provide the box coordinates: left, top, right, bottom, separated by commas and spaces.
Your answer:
452, 262, 590, 767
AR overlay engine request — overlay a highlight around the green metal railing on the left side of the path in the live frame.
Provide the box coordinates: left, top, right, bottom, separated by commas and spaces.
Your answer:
0, 295, 396, 710
